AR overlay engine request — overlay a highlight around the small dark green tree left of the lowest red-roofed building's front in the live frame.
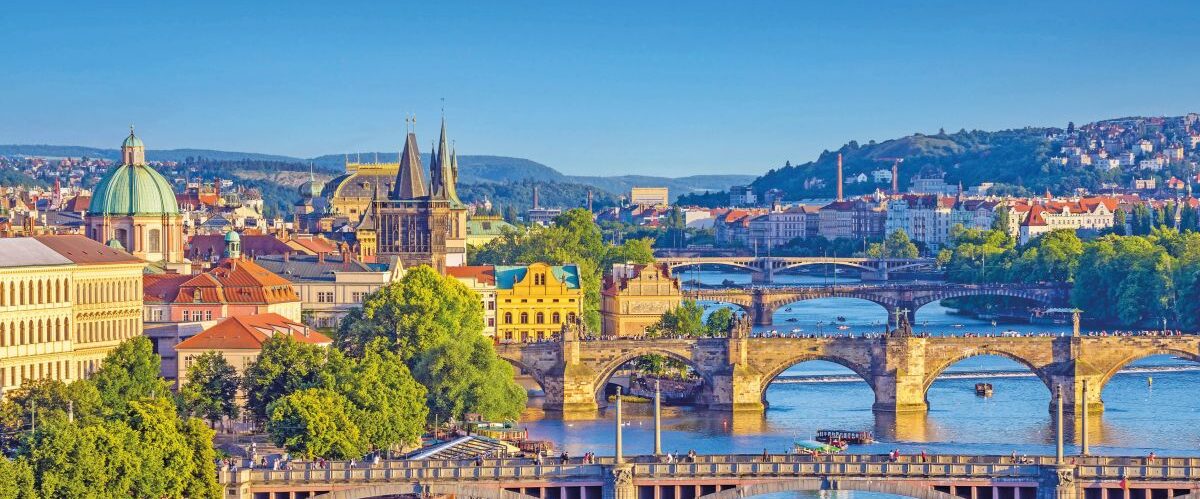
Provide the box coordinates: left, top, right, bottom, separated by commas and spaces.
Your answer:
180, 351, 241, 425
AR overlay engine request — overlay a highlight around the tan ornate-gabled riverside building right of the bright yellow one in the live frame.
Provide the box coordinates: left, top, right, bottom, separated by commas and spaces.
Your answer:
600, 264, 683, 336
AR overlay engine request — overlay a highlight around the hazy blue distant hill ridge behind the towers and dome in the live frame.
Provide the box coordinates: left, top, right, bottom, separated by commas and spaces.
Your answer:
0, 145, 754, 199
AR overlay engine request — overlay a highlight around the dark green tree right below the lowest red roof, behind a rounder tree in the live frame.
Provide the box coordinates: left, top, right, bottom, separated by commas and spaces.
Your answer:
242, 335, 328, 421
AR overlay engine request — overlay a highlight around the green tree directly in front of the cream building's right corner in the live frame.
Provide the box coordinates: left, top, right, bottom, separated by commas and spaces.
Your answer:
91, 336, 170, 414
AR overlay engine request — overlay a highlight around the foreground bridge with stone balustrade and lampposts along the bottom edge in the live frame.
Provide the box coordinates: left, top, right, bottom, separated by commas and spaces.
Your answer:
218, 455, 1200, 499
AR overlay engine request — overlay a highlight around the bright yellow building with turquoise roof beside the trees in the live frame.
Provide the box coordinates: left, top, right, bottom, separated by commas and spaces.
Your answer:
496, 263, 583, 342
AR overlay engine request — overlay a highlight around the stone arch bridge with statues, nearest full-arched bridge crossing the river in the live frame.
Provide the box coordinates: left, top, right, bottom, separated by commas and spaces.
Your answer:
496, 326, 1200, 419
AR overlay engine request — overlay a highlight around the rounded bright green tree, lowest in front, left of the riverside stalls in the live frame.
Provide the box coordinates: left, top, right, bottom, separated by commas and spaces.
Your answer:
266, 389, 366, 459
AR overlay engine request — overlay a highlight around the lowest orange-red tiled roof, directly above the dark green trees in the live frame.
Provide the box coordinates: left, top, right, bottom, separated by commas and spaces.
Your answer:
175, 313, 332, 350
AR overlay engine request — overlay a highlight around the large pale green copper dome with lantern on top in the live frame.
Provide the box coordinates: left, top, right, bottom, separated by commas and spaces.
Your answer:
88, 163, 179, 216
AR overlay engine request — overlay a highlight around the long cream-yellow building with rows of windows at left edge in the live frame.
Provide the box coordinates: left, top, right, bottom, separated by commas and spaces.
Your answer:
0, 235, 145, 392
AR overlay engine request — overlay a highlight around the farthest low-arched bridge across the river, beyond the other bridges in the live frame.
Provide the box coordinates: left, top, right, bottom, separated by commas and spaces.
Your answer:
655, 255, 937, 283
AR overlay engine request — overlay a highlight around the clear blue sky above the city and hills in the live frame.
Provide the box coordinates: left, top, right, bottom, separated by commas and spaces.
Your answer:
0, 1, 1200, 176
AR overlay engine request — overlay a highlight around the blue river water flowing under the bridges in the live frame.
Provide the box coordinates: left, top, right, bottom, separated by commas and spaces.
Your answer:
522, 271, 1200, 463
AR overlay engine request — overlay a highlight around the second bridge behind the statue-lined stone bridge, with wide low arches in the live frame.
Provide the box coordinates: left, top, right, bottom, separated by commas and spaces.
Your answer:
686, 283, 1070, 326
